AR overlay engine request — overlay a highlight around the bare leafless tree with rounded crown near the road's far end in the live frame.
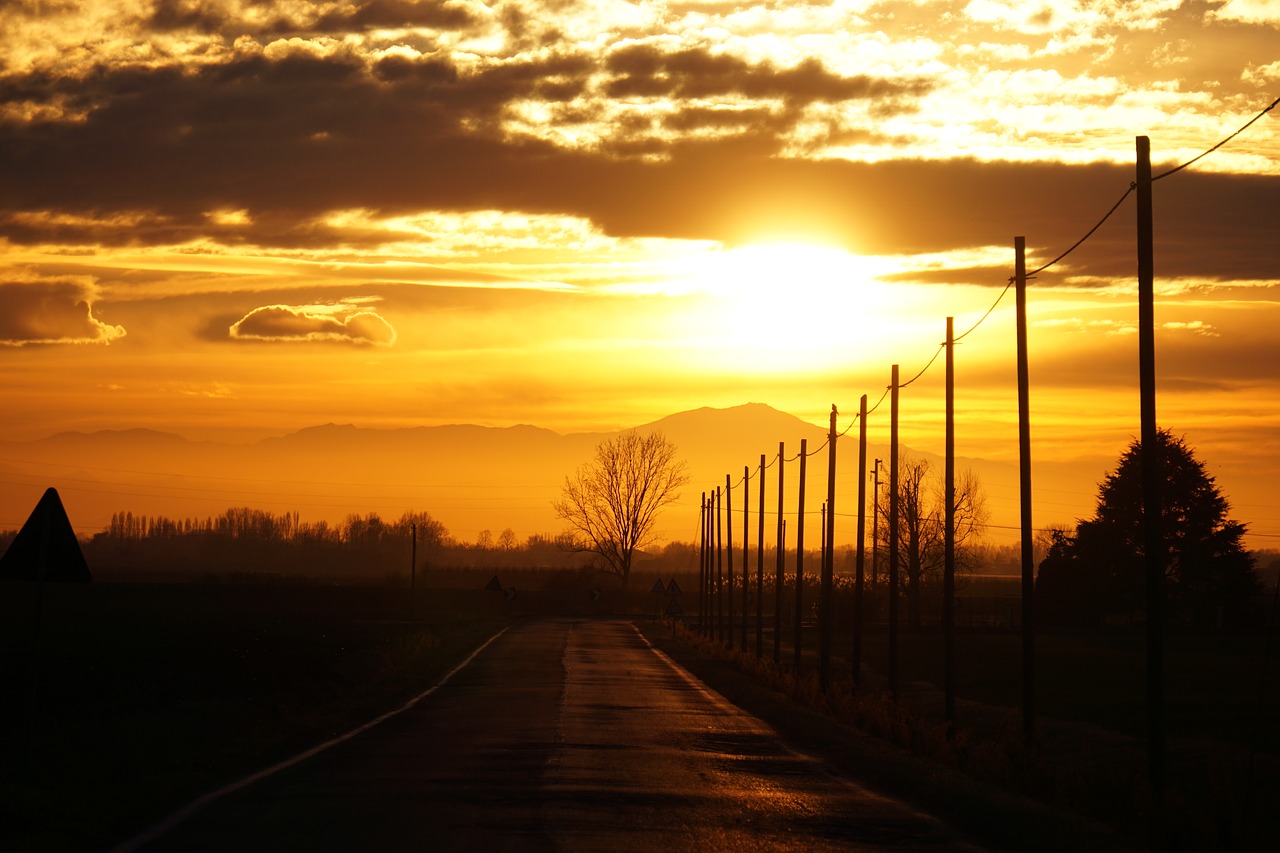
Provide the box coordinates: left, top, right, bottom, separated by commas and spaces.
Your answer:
552, 430, 689, 587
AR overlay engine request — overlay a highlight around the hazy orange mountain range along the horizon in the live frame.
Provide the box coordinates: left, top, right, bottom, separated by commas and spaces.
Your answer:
0, 403, 1105, 540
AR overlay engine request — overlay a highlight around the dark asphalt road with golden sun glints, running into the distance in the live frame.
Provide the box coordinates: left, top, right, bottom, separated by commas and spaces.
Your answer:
122, 619, 975, 852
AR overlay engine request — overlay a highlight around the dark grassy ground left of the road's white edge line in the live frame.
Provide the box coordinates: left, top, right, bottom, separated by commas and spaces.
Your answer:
0, 584, 507, 850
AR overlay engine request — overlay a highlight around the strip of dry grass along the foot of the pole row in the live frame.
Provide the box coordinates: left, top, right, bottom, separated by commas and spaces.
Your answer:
675, 617, 1277, 852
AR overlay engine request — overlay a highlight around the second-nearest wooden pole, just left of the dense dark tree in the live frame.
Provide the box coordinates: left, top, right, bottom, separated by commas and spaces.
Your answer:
1014, 237, 1036, 743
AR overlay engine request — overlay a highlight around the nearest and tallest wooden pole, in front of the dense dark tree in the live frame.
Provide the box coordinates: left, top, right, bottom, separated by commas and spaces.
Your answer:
1137, 136, 1165, 804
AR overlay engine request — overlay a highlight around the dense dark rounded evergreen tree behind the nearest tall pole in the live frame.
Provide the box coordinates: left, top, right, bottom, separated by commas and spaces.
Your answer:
1037, 429, 1261, 625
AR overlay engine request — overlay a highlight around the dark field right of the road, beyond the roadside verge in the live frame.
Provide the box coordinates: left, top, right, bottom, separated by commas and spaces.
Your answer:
681, 607, 1280, 852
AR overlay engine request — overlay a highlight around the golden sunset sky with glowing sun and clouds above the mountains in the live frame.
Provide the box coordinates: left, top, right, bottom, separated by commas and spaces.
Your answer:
0, 0, 1280, 547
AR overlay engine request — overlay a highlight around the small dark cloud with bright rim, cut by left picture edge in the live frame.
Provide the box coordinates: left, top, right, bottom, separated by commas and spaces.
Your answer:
0, 280, 124, 346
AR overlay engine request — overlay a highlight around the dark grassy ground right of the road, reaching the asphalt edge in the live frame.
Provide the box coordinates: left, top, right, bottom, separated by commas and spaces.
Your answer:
648, 617, 1280, 850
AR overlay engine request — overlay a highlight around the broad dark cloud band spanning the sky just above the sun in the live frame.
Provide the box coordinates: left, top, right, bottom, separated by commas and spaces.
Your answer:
0, 47, 1280, 280
